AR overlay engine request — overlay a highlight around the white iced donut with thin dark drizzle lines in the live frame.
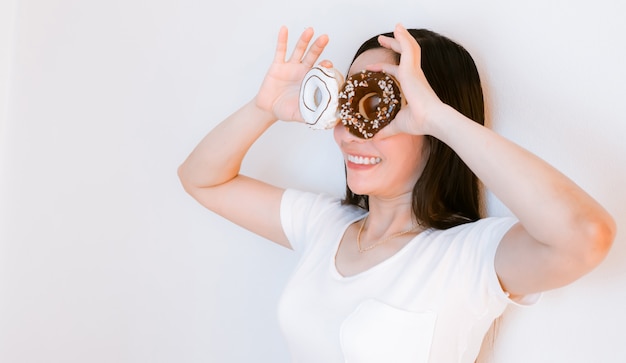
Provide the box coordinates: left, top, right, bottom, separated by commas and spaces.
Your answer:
300, 66, 343, 130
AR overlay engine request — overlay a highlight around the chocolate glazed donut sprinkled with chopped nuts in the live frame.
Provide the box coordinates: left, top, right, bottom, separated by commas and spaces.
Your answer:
339, 71, 402, 139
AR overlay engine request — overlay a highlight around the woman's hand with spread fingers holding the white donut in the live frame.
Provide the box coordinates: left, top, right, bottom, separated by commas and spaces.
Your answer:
256, 26, 332, 121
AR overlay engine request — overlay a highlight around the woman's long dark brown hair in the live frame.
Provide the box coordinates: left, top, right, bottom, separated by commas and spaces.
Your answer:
344, 29, 485, 229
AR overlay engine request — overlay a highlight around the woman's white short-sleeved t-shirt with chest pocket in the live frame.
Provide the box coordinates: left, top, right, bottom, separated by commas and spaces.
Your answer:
279, 189, 536, 363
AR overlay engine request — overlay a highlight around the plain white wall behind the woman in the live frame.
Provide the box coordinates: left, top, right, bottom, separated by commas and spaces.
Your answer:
0, 0, 626, 363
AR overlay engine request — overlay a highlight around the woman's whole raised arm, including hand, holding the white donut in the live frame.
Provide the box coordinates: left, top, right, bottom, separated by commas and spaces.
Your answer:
178, 27, 328, 247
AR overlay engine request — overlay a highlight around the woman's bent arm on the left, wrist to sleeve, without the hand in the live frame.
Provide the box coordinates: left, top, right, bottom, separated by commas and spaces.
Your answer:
178, 101, 289, 247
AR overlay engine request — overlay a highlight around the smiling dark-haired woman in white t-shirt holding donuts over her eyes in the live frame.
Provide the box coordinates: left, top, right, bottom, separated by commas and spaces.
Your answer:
179, 25, 615, 362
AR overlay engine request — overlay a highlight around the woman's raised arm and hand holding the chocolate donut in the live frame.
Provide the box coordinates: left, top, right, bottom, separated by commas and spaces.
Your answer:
372, 26, 615, 296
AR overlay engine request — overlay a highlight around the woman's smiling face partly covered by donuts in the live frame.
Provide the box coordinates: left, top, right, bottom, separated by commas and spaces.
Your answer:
334, 48, 426, 198
